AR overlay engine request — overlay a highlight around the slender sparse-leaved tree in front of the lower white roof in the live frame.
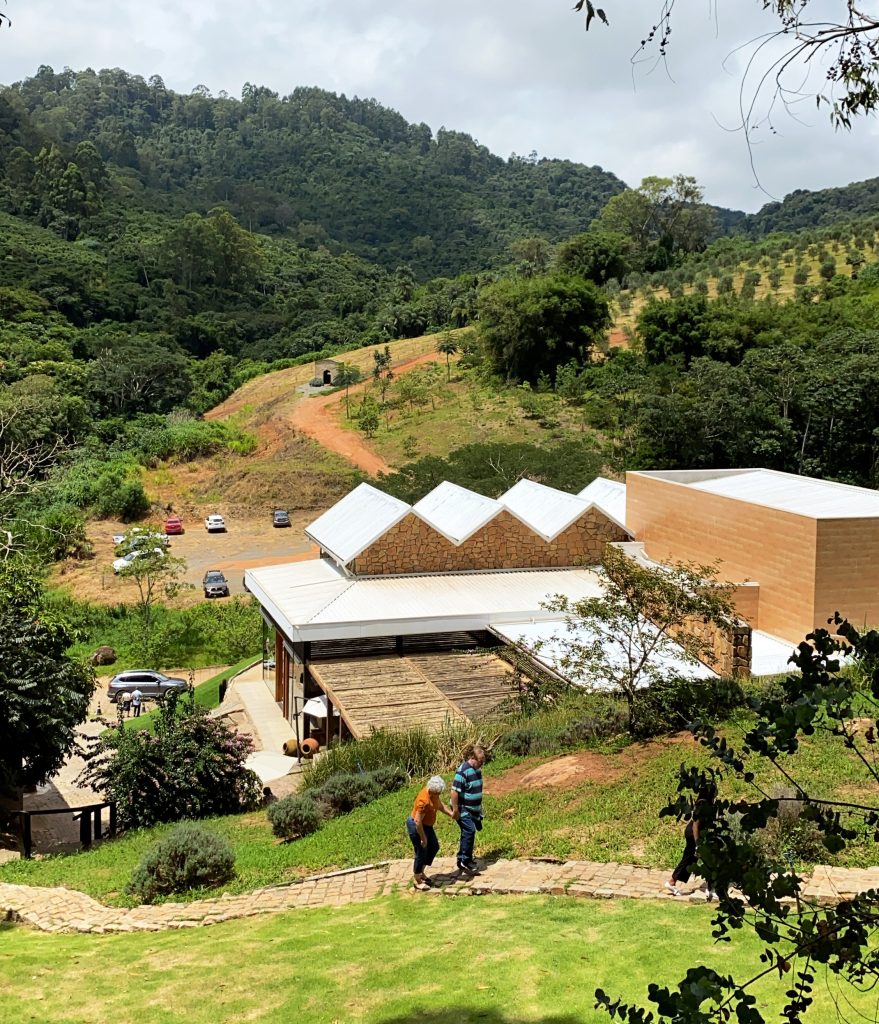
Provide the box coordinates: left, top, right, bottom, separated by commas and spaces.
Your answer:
546, 547, 734, 731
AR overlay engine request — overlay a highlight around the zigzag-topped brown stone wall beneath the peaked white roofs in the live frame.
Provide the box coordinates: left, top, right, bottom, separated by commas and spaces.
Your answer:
348, 508, 628, 575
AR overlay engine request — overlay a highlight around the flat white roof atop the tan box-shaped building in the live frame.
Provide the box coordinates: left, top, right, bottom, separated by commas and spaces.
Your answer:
645, 469, 879, 519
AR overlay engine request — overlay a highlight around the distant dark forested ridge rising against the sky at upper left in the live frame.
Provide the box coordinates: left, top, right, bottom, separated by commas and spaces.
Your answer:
0, 68, 625, 278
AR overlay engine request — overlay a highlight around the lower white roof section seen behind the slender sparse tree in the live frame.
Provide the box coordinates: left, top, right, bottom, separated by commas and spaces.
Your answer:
492, 617, 717, 685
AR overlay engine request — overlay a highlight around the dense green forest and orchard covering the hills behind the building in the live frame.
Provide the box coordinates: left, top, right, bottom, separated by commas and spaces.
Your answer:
0, 61, 879, 585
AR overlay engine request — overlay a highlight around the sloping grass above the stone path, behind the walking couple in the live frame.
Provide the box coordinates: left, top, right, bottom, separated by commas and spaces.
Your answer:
0, 712, 875, 904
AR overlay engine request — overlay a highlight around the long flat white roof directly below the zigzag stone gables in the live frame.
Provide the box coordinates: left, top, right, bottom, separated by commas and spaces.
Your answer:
246, 560, 601, 640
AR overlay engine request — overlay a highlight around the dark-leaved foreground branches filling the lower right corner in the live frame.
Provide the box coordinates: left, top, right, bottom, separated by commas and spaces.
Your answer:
595, 614, 879, 1024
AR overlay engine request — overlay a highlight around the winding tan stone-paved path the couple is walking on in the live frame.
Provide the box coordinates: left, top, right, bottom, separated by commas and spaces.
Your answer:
0, 858, 879, 933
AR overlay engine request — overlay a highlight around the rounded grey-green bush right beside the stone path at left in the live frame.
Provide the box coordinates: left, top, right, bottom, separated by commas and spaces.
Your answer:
127, 821, 235, 903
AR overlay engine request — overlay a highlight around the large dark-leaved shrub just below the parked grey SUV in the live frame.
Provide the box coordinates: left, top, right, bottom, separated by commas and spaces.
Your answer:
77, 693, 262, 828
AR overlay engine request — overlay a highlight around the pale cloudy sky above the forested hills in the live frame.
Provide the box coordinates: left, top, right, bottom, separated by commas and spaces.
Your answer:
0, 0, 879, 211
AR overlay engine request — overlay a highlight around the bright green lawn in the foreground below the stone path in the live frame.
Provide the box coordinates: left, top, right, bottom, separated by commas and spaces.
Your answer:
0, 894, 852, 1024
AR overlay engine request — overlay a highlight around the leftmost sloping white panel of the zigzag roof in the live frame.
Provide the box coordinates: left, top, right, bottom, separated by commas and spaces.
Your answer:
305, 483, 411, 565
